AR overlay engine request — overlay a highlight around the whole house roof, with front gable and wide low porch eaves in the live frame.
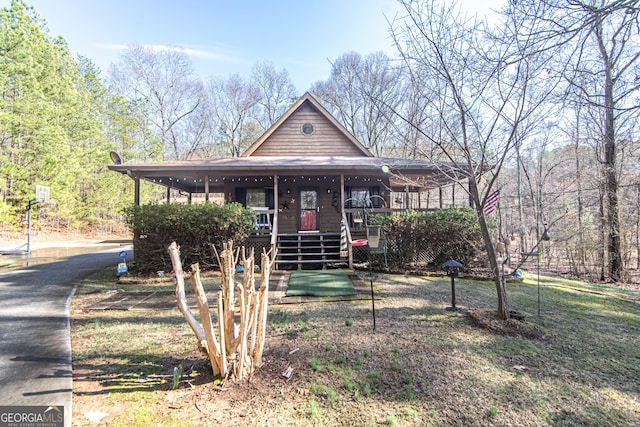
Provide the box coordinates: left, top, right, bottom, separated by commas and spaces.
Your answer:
109, 92, 472, 193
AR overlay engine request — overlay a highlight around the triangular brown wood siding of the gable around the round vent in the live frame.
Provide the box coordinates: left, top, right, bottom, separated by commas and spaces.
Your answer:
251, 103, 365, 156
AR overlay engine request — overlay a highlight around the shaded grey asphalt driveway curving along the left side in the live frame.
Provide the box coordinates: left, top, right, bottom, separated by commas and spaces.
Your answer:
0, 245, 130, 426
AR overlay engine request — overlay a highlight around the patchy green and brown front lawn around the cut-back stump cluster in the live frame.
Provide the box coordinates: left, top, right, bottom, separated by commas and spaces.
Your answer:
71, 270, 640, 426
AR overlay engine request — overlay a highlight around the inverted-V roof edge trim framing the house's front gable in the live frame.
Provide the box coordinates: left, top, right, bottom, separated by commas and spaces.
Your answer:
242, 92, 374, 157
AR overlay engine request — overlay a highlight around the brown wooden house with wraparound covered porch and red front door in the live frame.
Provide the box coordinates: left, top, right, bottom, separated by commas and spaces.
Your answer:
109, 93, 469, 268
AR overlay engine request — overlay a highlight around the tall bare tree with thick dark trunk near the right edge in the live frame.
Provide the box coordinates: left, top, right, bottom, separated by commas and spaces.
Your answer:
516, 0, 640, 281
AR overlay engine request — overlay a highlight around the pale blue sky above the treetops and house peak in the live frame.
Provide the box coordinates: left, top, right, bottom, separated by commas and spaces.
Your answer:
6, 0, 500, 93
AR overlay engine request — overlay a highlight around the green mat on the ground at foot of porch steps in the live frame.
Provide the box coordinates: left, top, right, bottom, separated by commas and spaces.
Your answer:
287, 269, 357, 297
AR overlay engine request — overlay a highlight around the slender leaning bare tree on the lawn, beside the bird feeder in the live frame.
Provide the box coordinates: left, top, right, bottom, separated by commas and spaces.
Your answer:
393, 0, 553, 319
